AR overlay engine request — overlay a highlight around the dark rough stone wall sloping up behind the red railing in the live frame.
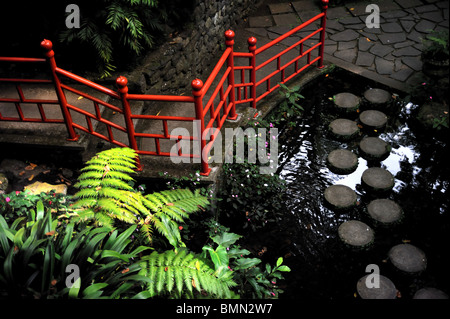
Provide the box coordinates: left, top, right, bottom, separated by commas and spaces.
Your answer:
124, 0, 258, 94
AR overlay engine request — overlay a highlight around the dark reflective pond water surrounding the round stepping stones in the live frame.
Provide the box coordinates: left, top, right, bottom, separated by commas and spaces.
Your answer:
272, 71, 450, 300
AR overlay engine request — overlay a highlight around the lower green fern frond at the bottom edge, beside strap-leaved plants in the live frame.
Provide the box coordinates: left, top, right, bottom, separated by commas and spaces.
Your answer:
139, 249, 236, 298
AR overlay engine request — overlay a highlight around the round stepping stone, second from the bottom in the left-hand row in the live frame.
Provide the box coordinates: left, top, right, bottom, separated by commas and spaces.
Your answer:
338, 220, 375, 248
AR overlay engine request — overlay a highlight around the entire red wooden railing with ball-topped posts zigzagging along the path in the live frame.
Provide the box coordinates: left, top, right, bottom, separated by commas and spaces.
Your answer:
0, 0, 328, 176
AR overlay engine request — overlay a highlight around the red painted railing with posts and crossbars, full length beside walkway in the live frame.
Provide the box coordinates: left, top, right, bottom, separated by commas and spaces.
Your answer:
0, 0, 328, 175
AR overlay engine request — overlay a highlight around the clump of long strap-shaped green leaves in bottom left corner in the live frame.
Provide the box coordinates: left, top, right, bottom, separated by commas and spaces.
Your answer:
0, 201, 149, 298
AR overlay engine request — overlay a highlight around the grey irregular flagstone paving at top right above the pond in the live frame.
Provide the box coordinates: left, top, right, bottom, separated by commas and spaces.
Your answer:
246, 0, 449, 91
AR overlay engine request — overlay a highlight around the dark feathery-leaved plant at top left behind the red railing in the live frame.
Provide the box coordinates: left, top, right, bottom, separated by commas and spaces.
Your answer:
60, 0, 164, 77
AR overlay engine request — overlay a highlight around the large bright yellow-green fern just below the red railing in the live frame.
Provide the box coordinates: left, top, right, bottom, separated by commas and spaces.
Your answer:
73, 148, 209, 247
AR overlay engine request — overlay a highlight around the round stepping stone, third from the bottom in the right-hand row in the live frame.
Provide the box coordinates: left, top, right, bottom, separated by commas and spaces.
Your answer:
367, 198, 403, 225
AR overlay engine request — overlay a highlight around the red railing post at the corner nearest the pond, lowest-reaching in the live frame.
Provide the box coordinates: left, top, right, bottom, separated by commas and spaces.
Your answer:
191, 79, 211, 176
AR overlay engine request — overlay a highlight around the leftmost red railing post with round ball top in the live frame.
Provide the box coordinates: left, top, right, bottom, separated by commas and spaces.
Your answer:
41, 39, 79, 141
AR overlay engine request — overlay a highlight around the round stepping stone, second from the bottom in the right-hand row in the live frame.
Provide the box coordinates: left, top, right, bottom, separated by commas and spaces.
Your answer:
388, 244, 427, 273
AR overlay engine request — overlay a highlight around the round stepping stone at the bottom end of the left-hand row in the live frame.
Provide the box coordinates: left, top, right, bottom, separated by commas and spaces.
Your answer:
356, 274, 397, 299
